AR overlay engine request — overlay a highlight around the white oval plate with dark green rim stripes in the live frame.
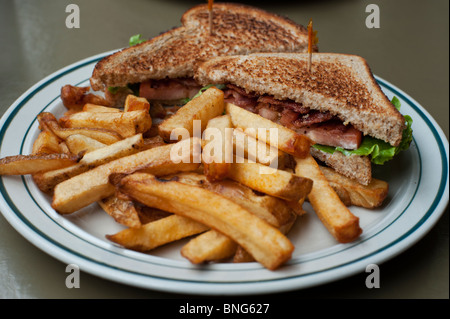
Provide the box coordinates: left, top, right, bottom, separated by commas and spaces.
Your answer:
0, 52, 449, 295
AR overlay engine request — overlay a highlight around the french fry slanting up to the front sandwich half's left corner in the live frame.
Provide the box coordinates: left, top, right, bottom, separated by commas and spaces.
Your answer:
158, 87, 224, 142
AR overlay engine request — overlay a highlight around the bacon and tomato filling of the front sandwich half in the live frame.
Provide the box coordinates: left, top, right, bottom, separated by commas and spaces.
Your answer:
224, 84, 363, 150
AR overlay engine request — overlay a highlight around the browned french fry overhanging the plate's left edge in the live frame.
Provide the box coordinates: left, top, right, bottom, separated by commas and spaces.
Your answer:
0, 154, 80, 175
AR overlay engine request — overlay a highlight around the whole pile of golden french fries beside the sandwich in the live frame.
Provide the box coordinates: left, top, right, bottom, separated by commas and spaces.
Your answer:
0, 87, 388, 270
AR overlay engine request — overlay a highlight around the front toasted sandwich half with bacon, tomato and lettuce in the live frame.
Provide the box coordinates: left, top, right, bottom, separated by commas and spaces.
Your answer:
195, 53, 409, 185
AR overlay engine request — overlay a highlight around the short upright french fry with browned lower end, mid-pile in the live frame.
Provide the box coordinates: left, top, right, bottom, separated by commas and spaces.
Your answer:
202, 115, 233, 181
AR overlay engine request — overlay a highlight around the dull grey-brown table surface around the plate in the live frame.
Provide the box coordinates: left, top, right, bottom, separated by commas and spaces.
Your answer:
0, 0, 449, 299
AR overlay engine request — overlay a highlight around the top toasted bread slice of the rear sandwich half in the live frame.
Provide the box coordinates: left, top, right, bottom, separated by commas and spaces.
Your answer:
90, 3, 317, 90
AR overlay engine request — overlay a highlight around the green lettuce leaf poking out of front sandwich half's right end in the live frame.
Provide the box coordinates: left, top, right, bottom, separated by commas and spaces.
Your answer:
313, 96, 413, 165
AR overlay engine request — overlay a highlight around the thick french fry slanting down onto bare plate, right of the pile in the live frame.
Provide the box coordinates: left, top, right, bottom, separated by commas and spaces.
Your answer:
295, 156, 362, 243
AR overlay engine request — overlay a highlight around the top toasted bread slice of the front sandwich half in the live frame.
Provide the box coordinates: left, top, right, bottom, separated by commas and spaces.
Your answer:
195, 53, 405, 146
